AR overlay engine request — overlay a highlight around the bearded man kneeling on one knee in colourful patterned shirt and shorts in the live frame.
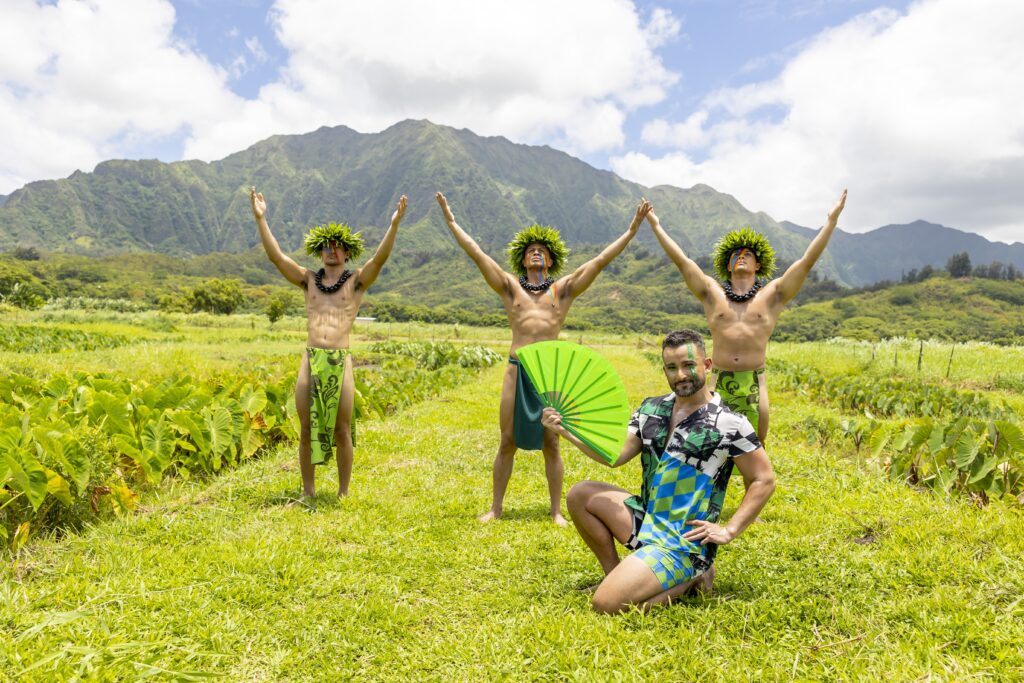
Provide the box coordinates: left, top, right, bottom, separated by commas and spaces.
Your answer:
542, 330, 775, 613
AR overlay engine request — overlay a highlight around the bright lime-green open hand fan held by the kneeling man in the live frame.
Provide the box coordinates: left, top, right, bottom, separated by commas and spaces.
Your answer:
516, 341, 632, 464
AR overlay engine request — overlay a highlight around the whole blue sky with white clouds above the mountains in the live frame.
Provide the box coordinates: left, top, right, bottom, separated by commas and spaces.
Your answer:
0, 0, 1024, 241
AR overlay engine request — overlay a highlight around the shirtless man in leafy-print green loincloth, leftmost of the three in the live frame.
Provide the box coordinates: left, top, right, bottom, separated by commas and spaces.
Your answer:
250, 187, 407, 498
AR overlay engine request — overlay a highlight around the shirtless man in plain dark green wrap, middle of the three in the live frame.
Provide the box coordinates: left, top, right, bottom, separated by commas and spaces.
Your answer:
437, 193, 650, 526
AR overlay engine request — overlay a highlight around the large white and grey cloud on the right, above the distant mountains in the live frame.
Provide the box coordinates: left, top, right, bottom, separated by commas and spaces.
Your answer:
611, 0, 1024, 240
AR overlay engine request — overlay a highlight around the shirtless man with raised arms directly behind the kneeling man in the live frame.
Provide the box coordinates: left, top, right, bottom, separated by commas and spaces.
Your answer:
647, 189, 846, 442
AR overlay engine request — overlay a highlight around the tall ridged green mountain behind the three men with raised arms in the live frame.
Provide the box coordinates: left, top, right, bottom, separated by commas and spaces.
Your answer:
0, 121, 846, 282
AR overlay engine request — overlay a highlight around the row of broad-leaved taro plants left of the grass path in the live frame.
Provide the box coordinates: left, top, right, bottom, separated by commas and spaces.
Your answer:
0, 342, 501, 550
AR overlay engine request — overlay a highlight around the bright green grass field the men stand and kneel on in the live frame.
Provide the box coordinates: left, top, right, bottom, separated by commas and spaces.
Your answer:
0, 313, 1024, 681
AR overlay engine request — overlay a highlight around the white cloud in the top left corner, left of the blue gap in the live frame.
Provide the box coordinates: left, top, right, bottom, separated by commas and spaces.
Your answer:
0, 0, 239, 191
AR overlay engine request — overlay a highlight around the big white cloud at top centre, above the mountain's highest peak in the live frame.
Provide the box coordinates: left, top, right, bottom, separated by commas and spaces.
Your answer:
186, 0, 680, 159
